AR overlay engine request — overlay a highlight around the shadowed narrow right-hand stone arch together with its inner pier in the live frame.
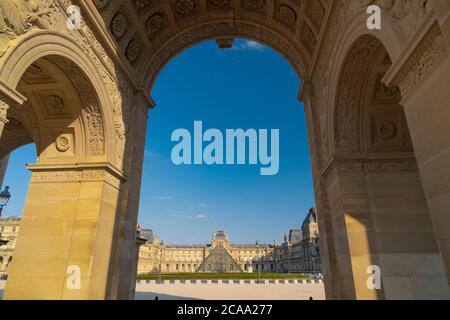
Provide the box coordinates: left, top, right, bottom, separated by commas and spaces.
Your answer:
322, 34, 448, 299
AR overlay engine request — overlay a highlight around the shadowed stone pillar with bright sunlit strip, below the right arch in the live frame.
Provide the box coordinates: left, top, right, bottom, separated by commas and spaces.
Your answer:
327, 160, 450, 299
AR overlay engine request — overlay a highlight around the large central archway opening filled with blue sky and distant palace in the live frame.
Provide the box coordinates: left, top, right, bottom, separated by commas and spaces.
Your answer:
137, 39, 323, 298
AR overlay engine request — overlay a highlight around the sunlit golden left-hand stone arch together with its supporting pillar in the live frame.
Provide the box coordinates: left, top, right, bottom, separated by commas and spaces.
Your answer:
0, 31, 128, 299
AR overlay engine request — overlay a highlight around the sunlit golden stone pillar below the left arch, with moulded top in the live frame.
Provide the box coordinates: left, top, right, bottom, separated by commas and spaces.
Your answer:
4, 163, 123, 300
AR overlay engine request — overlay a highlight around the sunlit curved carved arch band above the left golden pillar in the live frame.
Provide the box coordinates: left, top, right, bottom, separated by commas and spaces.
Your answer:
0, 32, 115, 162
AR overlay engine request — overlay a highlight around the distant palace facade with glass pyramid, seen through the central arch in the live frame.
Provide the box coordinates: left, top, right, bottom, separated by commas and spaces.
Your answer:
138, 209, 321, 274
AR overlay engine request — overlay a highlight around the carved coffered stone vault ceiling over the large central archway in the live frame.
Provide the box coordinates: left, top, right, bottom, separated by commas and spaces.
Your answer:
92, 0, 330, 86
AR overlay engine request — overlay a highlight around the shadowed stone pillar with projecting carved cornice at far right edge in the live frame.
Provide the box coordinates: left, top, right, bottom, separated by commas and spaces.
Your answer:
386, 21, 450, 285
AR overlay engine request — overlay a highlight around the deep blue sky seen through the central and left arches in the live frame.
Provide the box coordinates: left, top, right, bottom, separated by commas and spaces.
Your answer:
4, 40, 314, 243
